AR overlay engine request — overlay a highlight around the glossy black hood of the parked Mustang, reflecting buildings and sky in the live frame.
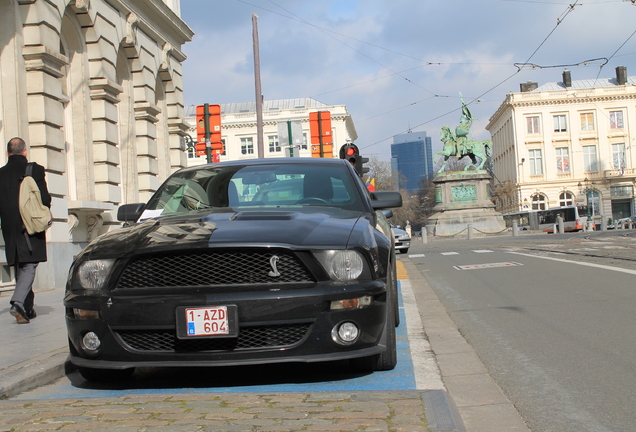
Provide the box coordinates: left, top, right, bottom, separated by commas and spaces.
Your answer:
84, 207, 370, 258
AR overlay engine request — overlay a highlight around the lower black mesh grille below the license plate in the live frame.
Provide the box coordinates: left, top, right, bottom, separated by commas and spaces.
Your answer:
116, 323, 311, 352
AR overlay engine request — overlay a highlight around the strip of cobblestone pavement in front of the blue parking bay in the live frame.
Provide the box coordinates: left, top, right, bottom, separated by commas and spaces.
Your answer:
0, 392, 439, 432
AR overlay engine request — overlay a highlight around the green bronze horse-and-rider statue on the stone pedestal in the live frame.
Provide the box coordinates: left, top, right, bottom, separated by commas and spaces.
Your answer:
433, 94, 492, 174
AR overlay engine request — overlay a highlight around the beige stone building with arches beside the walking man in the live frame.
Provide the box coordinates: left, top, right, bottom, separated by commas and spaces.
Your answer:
0, 0, 193, 291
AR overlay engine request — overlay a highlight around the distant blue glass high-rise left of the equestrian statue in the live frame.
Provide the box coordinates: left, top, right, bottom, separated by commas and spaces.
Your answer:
391, 132, 433, 193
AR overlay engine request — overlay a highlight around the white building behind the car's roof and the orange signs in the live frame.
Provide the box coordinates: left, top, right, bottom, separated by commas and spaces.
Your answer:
186, 98, 358, 165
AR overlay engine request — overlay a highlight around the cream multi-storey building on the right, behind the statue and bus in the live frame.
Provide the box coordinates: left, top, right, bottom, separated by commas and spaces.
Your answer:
486, 67, 636, 224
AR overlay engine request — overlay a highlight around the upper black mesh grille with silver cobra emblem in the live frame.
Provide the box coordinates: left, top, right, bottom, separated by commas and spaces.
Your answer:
117, 249, 315, 288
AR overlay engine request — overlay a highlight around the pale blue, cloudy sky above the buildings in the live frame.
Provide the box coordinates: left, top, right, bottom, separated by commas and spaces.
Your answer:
176, 0, 636, 161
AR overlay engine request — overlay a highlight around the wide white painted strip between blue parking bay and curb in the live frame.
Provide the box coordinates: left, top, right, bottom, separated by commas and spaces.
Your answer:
400, 280, 446, 390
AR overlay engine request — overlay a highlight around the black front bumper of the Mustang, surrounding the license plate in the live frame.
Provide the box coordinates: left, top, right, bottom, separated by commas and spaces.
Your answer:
64, 281, 387, 369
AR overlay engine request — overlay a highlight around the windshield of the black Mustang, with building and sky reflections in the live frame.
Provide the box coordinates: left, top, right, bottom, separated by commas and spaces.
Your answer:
144, 164, 364, 217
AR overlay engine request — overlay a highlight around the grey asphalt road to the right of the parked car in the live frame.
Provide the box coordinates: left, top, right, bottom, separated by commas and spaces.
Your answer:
409, 231, 636, 432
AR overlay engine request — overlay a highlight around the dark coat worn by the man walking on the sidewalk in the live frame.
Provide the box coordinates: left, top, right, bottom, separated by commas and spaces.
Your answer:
0, 155, 51, 265
